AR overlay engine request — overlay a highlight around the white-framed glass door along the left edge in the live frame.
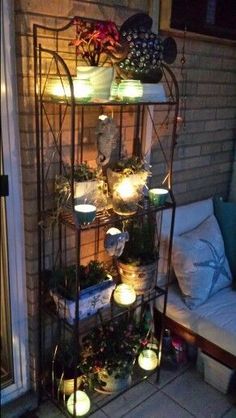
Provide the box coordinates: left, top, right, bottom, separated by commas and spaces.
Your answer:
0, 0, 29, 404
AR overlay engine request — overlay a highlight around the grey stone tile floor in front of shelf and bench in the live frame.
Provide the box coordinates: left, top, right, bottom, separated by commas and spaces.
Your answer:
33, 365, 236, 418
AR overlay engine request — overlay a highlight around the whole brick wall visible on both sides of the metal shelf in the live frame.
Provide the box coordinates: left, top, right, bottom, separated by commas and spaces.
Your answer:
15, 0, 236, 392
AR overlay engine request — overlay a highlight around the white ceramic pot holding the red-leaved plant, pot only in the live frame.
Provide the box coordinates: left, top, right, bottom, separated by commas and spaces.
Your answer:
77, 66, 114, 100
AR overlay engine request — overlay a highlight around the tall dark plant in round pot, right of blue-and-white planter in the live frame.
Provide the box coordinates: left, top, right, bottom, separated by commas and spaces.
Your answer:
117, 217, 158, 295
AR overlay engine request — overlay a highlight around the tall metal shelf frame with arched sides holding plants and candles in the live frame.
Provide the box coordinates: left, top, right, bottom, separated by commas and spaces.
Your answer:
33, 15, 179, 416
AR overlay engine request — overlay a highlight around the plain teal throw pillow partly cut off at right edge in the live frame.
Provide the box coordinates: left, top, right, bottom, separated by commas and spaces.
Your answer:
214, 198, 236, 289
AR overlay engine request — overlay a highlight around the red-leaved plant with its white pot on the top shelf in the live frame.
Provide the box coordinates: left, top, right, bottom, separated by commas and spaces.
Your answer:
69, 17, 127, 99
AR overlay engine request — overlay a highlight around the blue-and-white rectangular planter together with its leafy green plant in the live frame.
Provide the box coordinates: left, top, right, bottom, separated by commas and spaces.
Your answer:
48, 260, 115, 324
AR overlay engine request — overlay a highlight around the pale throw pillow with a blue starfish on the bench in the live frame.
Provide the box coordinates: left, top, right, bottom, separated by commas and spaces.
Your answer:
172, 215, 232, 309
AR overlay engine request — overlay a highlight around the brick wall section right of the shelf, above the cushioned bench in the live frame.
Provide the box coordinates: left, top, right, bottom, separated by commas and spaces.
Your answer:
152, 32, 236, 204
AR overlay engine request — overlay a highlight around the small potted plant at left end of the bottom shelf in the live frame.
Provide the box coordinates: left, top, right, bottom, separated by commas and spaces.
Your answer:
52, 339, 85, 396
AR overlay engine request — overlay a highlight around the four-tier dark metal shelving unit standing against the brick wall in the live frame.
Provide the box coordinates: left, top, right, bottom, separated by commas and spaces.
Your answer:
33, 14, 179, 416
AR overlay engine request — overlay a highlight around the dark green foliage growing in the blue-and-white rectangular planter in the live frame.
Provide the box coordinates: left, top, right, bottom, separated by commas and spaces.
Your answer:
48, 260, 109, 300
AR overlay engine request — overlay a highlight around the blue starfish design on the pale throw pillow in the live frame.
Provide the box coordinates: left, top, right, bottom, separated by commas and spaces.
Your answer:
193, 239, 231, 296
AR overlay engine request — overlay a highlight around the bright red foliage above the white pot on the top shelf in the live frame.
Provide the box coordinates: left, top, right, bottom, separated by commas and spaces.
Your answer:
69, 17, 126, 66
